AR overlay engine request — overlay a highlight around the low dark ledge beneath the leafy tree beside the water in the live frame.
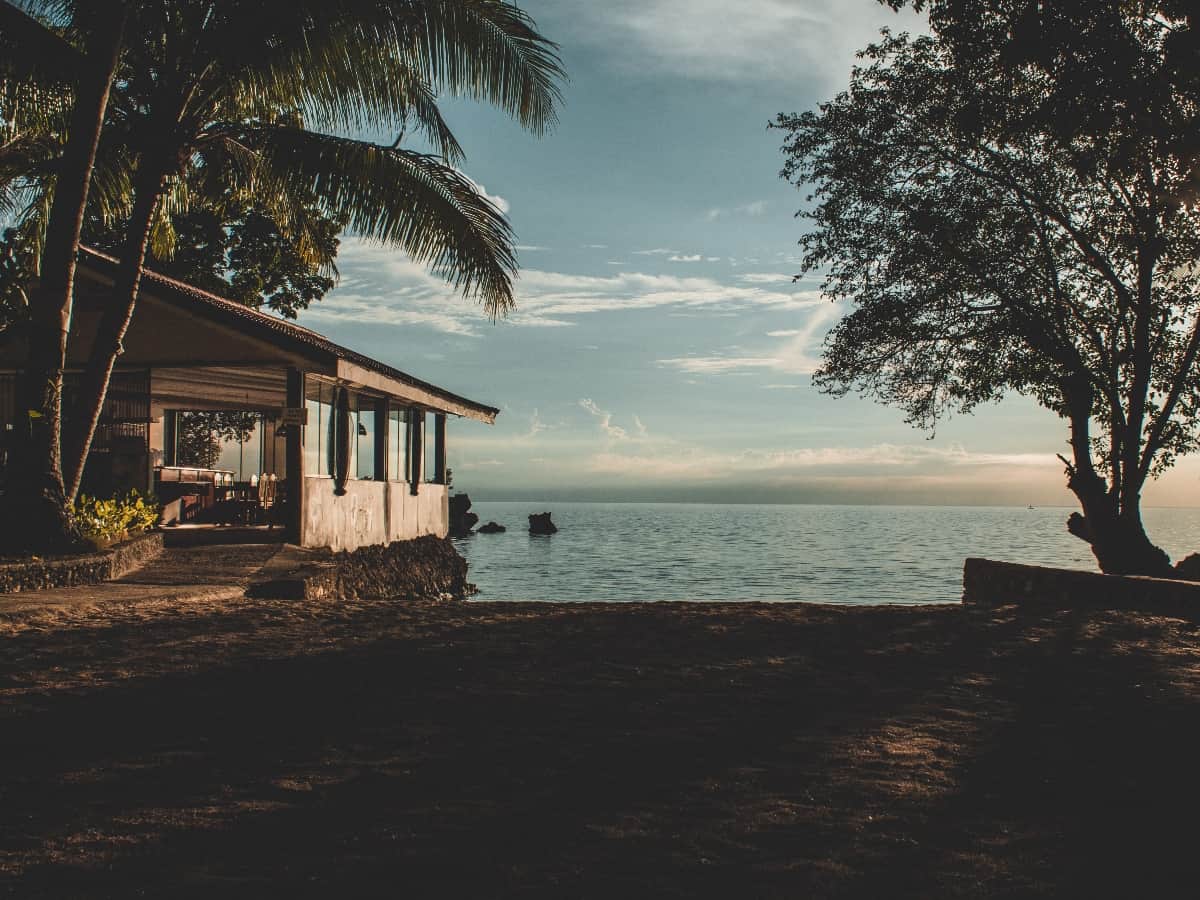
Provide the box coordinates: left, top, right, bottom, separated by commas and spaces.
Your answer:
962, 558, 1200, 617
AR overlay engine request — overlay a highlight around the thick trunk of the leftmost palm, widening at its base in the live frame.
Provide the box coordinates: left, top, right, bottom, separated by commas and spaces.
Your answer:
0, 4, 128, 553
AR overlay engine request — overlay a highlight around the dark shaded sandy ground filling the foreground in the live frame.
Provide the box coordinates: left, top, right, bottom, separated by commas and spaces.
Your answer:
0, 600, 1200, 899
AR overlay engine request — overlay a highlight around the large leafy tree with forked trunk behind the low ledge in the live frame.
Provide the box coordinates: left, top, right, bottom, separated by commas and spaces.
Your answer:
778, 24, 1200, 575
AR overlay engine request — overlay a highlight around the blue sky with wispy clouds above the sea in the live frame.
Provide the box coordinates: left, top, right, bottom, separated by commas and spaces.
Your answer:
300, 0, 1200, 505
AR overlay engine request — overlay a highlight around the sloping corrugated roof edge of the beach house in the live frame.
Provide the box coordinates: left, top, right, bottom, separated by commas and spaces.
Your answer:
79, 247, 500, 416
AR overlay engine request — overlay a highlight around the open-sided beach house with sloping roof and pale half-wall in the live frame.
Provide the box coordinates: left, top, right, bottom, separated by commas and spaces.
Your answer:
0, 250, 499, 550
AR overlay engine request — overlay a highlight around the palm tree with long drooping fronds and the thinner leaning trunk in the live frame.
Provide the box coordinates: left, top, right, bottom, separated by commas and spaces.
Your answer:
0, 0, 562, 554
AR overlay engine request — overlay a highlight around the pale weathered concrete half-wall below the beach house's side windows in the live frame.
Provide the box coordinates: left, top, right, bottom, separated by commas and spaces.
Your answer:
300, 476, 450, 550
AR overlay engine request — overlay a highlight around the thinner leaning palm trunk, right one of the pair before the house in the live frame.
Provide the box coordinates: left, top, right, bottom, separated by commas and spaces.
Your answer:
65, 165, 166, 502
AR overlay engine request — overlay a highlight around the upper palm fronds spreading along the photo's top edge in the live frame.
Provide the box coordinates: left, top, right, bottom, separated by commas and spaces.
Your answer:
188, 0, 565, 139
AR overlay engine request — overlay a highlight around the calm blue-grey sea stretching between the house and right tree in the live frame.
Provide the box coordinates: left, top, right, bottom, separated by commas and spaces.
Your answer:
455, 500, 1200, 604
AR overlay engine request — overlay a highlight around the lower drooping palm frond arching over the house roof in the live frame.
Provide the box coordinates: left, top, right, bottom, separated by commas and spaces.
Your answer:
246, 126, 517, 318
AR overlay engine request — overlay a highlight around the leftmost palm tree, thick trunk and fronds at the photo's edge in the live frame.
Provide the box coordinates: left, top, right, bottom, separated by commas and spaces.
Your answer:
0, 1, 128, 548
